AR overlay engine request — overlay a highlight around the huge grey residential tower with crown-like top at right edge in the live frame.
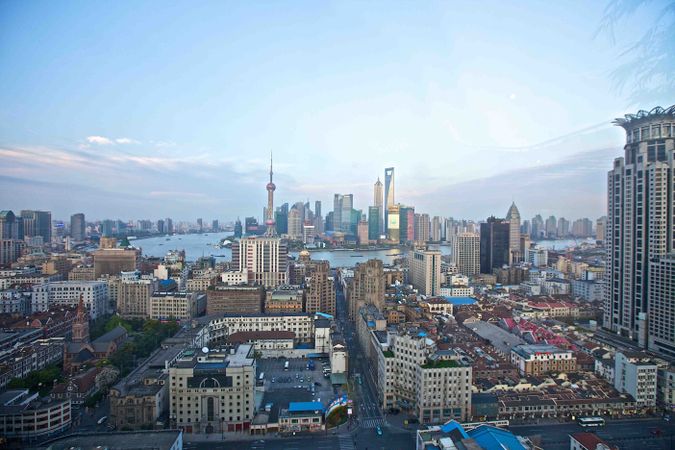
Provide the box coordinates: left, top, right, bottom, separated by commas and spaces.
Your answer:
604, 105, 675, 357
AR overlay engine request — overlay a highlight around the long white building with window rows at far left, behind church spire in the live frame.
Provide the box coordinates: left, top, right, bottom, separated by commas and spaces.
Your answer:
31, 281, 108, 320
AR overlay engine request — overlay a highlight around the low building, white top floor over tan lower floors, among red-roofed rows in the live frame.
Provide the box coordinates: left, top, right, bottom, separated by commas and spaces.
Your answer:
511, 344, 576, 375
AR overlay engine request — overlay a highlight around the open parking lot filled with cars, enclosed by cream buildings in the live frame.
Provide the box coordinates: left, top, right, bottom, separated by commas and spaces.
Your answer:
258, 358, 338, 408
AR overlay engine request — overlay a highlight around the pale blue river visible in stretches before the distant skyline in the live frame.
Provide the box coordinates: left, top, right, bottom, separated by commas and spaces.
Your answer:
131, 232, 594, 267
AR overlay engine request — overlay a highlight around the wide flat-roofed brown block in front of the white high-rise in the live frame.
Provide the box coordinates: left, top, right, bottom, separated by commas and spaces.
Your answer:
206, 285, 265, 314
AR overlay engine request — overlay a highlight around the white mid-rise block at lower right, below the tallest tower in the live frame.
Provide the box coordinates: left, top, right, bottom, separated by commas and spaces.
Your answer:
614, 352, 658, 407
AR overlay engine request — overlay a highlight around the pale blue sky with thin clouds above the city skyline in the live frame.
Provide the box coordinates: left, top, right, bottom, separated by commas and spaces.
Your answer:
0, 0, 675, 220
